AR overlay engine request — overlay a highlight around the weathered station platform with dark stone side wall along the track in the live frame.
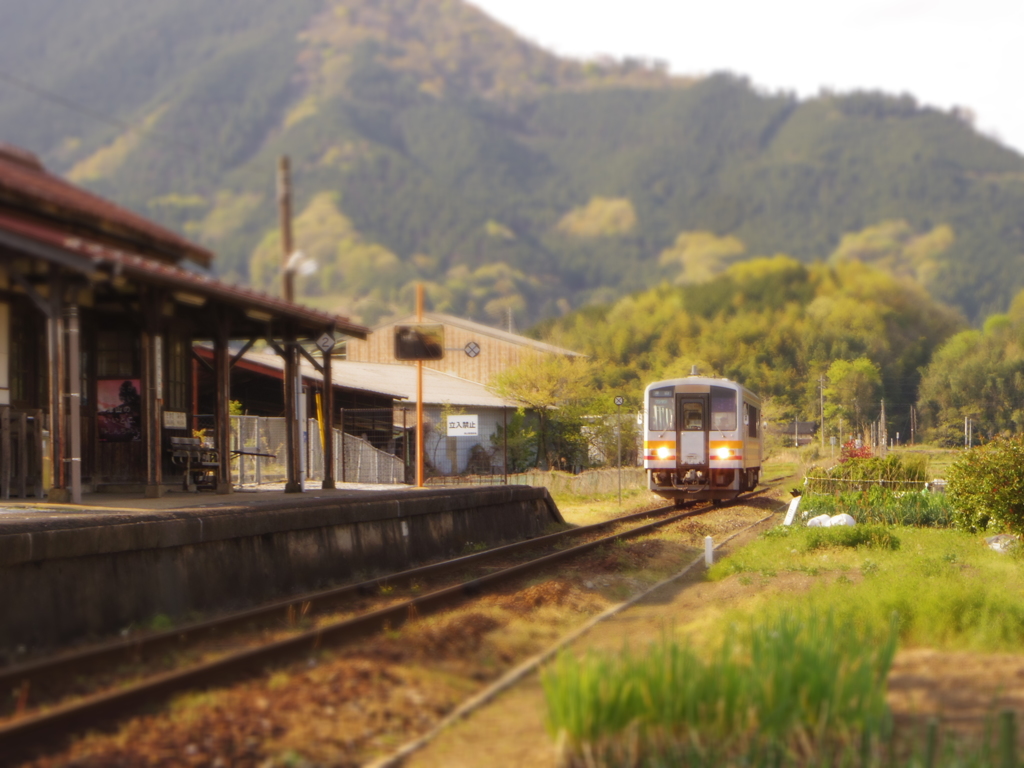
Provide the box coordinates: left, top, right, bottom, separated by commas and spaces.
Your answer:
0, 483, 563, 656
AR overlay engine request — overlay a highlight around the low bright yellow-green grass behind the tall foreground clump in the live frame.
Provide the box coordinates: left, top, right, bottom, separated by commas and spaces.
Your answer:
709, 526, 1024, 651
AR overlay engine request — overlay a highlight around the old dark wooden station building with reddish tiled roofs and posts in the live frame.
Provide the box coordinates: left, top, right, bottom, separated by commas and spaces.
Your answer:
0, 144, 367, 502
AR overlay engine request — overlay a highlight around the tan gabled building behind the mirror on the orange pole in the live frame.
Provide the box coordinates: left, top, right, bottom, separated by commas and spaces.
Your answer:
345, 312, 586, 385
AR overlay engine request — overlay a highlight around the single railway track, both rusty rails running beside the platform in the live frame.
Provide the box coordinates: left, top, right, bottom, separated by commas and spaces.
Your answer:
0, 489, 778, 757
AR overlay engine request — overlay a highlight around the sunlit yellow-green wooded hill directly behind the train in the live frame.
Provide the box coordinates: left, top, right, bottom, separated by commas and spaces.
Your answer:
535, 256, 963, 436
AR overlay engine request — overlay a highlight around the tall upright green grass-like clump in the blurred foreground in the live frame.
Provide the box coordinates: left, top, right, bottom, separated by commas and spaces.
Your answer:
543, 611, 897, 766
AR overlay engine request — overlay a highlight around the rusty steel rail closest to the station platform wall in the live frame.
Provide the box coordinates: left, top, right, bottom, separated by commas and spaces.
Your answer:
0, 506, 688, 690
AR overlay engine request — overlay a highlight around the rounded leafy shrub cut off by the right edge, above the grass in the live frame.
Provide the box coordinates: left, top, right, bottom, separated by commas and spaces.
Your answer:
946, 435, 1024, 534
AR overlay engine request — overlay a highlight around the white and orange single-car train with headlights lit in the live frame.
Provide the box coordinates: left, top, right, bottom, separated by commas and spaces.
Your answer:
643, 367, 764, 506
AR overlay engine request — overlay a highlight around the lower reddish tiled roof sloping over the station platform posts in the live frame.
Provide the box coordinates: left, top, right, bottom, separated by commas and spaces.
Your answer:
0, 213, 368, 338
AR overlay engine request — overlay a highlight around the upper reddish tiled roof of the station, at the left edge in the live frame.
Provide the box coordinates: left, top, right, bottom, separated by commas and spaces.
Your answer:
0, 143, 213, 266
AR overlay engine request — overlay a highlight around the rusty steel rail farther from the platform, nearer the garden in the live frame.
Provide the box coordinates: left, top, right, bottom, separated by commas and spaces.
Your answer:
0, 490, 763, 756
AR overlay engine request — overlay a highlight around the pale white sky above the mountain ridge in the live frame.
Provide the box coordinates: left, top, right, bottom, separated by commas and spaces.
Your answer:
472, 0, 1024, 153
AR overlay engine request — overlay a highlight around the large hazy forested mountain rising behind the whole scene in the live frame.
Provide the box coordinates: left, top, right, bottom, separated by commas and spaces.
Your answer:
0, 0, 1024, 327
